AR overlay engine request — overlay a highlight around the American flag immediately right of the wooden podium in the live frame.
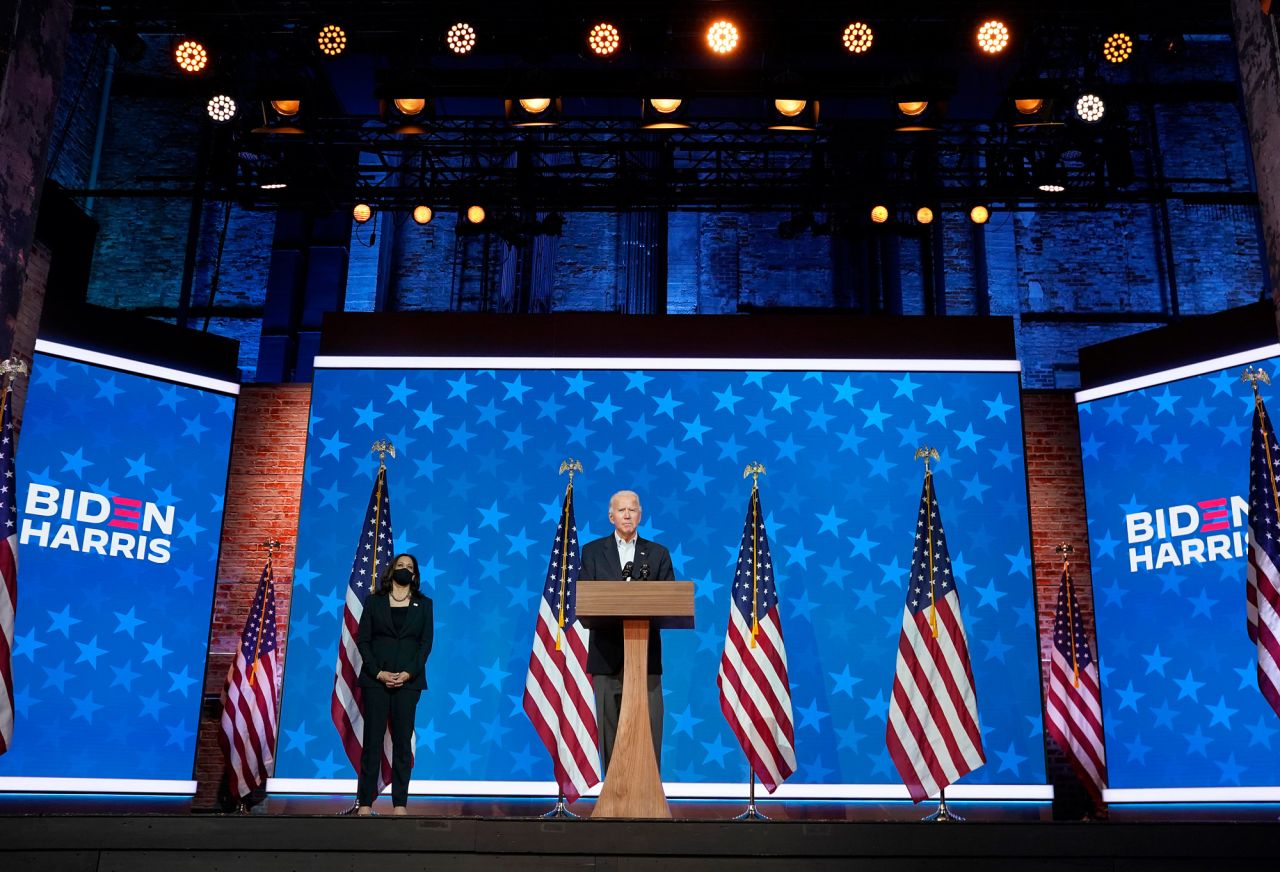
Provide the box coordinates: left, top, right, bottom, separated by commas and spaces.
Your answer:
716, 484, 796, 793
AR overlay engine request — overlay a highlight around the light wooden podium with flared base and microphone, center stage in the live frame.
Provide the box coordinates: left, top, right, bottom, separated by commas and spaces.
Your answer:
576, 580, 694, 820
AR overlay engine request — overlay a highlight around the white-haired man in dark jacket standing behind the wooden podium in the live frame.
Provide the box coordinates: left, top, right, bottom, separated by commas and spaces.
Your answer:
579, 490, 676, 771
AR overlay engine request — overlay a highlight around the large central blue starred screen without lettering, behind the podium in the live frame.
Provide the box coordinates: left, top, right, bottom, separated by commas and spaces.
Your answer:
276, 369, 1044, 784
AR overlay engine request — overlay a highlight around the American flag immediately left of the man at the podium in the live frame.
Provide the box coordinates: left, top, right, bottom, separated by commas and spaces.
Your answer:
525, 481, 600, 803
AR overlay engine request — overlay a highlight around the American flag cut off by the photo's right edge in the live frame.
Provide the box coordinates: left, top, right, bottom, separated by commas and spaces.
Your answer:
1245, 385, 1280, 715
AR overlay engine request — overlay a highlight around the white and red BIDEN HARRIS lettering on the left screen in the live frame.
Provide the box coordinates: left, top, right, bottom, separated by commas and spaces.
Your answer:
18, 484, 174, 563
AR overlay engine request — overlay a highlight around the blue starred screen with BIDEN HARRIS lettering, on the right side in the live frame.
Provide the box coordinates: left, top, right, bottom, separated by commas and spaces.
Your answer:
1079, 359, 1280, 787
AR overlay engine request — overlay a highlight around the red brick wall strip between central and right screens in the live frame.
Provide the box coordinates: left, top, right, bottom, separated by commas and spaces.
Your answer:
1023, 391, 1097, 817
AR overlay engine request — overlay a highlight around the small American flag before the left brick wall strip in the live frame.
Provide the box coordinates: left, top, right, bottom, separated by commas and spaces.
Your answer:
218, 558, 279, 798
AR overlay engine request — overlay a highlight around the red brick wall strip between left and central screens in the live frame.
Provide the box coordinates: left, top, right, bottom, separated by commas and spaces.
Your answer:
193, 384, 311, 809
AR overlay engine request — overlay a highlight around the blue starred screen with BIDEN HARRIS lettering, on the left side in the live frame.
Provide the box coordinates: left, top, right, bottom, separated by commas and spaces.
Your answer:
0, 352, 236, 781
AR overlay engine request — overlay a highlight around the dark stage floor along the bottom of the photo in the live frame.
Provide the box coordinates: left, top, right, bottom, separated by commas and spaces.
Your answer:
0, 796, 1280, 872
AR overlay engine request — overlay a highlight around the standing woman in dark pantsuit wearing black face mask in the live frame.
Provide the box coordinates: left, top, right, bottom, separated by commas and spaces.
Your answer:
357, 554, 435, 814
